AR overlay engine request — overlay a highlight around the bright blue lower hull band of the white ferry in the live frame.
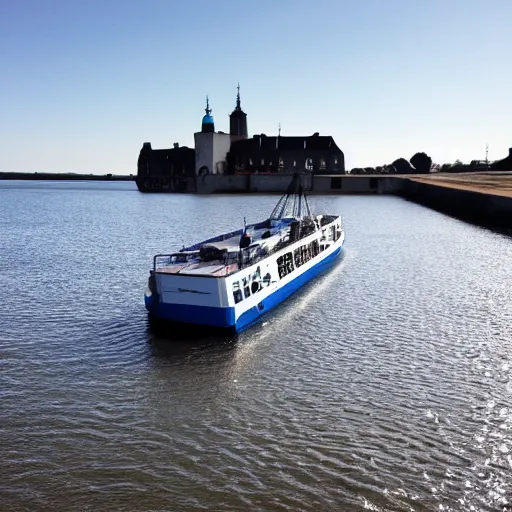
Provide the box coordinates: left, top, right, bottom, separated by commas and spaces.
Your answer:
144, 247, 343, 332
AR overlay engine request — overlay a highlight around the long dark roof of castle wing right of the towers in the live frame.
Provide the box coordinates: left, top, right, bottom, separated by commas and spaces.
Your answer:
231, 135, 341, 153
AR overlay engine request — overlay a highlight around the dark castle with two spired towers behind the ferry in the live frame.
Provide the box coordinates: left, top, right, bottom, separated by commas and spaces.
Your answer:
136, 85, 345, 192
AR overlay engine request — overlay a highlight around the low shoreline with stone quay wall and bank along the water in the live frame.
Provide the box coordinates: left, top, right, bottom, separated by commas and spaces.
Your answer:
0, 171, 512, 229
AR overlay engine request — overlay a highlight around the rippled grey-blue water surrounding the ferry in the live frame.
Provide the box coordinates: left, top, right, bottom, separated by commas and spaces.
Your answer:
0, 182, 512, 511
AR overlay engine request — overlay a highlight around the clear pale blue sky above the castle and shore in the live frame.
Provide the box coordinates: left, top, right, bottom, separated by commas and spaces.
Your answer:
0, 0, 512, 174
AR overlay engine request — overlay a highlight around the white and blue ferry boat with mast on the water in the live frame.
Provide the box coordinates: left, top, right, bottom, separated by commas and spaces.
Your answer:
144, 175, 345, 332
